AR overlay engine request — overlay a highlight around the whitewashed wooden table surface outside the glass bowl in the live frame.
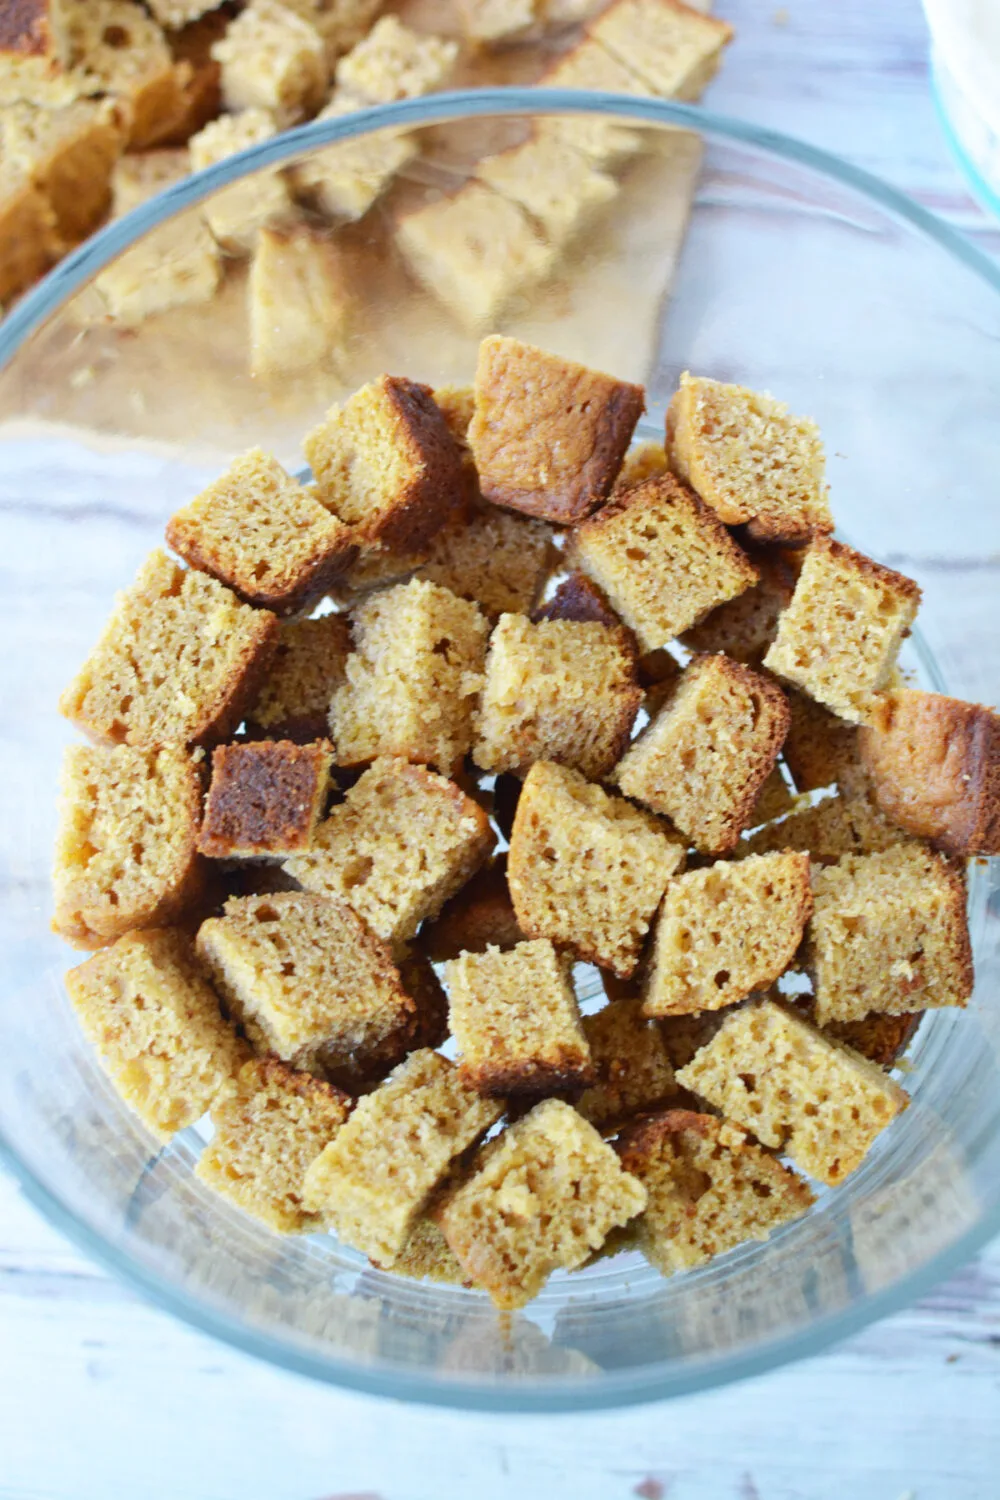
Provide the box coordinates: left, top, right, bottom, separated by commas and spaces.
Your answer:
0, 0, 1000, 1500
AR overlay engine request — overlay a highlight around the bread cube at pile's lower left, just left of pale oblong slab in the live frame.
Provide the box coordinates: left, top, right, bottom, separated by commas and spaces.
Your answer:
195, 1058, 352, 1235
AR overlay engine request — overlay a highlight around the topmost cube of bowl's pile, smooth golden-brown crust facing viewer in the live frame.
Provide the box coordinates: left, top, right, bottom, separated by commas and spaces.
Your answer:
469, 335, 645, 525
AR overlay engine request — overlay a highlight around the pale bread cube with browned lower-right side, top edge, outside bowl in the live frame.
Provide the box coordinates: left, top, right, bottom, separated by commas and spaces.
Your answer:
211, 0, 330, 126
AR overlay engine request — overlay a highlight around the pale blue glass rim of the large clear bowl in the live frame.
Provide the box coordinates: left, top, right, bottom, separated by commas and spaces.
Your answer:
0, 87, 1000, 1415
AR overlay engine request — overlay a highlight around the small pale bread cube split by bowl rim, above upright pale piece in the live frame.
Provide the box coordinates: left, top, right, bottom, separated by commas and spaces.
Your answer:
190, 110, 291, 255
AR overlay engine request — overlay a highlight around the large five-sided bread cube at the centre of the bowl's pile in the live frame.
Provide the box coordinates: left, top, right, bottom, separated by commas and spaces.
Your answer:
508, 761, 685, 980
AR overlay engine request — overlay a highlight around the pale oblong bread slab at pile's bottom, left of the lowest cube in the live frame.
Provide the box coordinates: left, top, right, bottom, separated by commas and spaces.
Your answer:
306, 1049, 502, 1266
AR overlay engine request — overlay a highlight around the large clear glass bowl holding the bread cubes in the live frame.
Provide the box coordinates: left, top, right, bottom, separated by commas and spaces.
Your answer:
0, 90, 1000, 1412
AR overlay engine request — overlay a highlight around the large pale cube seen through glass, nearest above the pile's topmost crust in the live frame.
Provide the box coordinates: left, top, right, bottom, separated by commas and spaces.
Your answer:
396, 182, 559, 333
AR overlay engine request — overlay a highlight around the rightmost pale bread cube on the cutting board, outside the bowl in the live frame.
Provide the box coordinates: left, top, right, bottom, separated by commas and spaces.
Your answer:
588, 0, 733, 99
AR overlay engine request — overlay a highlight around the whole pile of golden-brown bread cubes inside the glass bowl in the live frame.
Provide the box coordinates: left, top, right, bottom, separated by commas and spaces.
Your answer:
54, 336, 1000, 1308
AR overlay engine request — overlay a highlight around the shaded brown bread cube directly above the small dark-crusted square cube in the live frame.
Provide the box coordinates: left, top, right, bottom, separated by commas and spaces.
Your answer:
246, 615, 351, 744
